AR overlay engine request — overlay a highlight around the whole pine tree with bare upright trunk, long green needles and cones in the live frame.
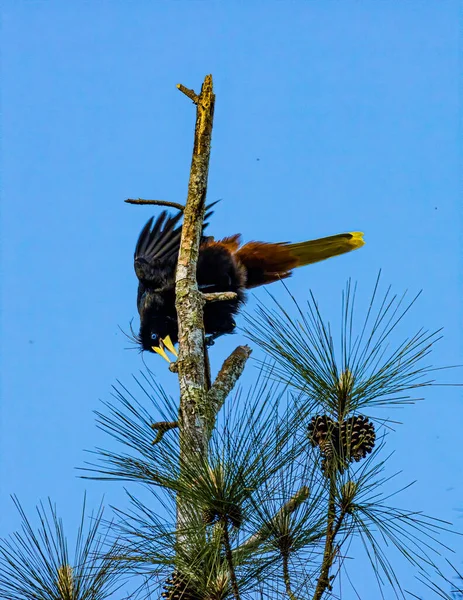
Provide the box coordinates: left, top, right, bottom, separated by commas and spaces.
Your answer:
0, 76, 462, 600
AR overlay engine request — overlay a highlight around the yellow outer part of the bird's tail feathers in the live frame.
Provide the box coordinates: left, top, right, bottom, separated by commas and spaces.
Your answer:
286, 231, 365, 267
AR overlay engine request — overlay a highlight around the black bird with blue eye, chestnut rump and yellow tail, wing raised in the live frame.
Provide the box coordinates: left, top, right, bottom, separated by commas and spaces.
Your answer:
133, 203, 365, 358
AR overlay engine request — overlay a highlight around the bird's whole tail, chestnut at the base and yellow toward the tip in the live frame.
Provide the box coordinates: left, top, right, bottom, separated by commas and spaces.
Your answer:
235, 231, 365, 289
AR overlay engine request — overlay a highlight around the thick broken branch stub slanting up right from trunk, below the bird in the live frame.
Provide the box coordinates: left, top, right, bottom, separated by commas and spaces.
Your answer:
207, 346, 252, 431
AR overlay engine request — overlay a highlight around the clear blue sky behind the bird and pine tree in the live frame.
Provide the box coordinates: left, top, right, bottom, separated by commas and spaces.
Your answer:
0, 0, 463, 600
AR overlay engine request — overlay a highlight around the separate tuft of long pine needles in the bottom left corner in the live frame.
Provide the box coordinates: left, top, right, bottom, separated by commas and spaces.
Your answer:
0, 498, 122, 600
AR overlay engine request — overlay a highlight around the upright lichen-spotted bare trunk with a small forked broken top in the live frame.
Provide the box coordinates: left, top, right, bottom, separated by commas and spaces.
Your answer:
175, 75, 215, 530
